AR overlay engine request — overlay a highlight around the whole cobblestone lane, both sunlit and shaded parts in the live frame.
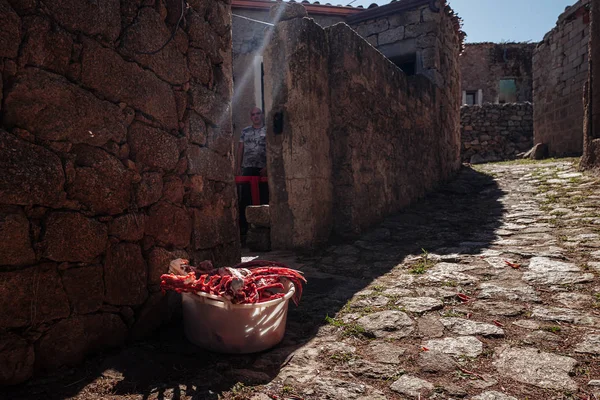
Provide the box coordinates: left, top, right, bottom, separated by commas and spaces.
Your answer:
8, 160, 600, 400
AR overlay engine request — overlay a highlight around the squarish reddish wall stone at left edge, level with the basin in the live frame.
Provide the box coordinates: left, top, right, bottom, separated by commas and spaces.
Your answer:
0, 264, 69, 328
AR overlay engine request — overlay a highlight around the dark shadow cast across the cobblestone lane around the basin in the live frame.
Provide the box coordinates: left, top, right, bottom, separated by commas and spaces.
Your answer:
5, 168, 505, 399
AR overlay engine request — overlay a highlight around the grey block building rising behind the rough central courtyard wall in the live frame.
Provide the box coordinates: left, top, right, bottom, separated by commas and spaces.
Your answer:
232, 0, 464, 139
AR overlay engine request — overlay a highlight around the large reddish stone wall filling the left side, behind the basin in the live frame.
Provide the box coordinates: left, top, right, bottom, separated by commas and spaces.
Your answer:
0, 0, 240, 384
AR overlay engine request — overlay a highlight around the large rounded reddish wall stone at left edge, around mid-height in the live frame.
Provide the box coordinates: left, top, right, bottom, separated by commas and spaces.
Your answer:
0, 129, 65, 206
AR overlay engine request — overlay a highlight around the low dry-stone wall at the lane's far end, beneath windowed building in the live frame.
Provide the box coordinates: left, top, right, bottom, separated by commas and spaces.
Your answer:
460, 103, 533, 164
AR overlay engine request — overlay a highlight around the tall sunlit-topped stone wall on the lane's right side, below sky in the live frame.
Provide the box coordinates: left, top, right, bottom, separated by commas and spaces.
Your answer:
533, 0, 590, 156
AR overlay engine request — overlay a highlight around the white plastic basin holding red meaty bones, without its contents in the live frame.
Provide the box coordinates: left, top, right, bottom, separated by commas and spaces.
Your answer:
182, 283, 295, 354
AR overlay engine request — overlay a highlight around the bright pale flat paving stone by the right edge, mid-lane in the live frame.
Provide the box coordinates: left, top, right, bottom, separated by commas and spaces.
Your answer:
523, 257, 594, 285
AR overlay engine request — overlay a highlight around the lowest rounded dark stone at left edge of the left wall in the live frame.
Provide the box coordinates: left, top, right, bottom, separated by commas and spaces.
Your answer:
0, 333, 35, 385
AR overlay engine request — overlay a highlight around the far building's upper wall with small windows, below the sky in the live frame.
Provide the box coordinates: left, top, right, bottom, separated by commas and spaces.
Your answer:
460, 43, 536, 105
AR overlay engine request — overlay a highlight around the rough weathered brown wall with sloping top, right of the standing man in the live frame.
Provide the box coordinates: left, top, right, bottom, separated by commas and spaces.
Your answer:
265, 4, 460, 249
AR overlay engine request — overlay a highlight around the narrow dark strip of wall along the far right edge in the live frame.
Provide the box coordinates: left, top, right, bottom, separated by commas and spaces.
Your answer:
580, 3, 600, 169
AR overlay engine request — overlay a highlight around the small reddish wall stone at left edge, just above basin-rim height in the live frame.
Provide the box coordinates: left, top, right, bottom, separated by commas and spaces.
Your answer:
0, 206, 35, 265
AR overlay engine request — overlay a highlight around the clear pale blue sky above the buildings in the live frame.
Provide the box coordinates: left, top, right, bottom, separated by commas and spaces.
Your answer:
350, 0, 576, 42
